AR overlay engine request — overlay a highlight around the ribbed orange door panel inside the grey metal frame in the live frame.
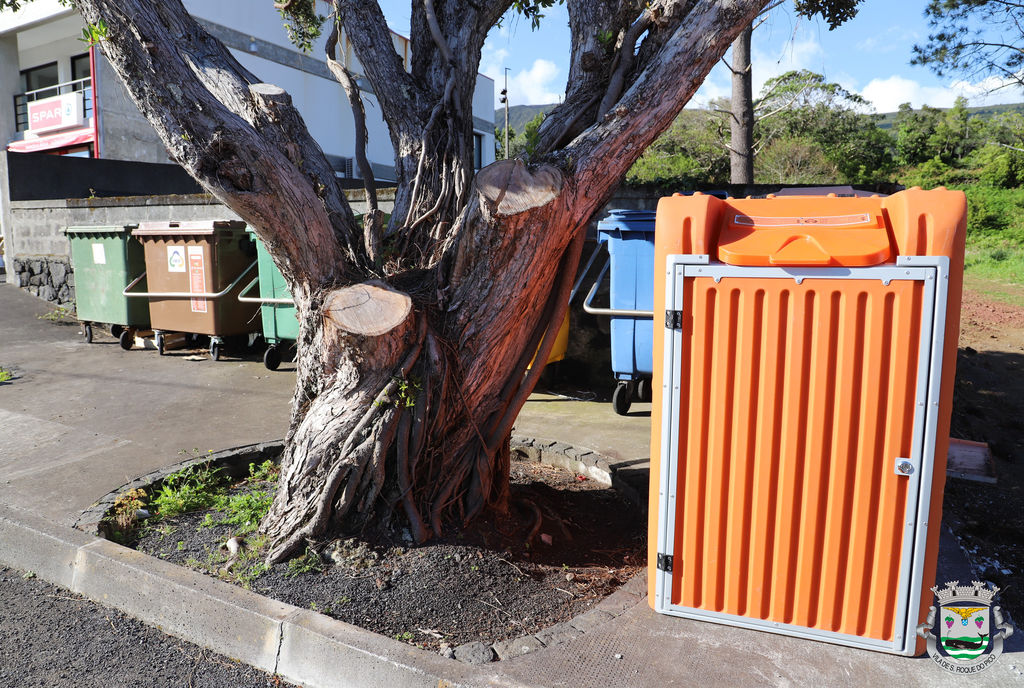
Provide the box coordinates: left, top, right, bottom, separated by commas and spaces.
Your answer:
672, 277, 924, 641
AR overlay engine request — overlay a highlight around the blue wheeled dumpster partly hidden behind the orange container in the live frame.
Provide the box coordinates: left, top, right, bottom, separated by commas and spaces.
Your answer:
590, 210, 655, 415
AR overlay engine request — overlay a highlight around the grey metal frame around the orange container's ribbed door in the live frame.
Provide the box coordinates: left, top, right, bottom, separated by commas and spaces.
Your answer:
654, 255, 949, 655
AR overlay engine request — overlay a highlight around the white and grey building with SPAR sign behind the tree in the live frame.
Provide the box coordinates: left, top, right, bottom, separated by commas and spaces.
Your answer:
0, 0, 495, 181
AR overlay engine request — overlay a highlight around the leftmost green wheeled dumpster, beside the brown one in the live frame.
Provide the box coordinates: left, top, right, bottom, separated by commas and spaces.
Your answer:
65, 225, 150, 350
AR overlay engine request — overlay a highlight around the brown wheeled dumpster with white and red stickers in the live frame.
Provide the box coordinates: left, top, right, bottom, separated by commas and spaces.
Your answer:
125, 220, 260, 360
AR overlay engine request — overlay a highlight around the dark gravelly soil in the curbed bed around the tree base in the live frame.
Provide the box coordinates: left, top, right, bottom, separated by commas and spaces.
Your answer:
136, 459, 646, 653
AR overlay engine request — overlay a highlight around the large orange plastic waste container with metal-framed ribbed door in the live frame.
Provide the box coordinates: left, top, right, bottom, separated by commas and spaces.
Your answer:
648, 188, 967, 655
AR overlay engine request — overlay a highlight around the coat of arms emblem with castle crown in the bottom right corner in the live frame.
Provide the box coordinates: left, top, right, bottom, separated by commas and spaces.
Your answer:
918, 581, 1014, 674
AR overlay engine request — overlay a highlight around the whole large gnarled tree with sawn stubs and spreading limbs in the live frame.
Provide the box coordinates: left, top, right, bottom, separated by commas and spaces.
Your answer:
76, 0, 765, 561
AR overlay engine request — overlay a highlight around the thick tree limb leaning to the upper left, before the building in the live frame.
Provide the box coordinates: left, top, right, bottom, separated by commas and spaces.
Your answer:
76, 0, 364, 286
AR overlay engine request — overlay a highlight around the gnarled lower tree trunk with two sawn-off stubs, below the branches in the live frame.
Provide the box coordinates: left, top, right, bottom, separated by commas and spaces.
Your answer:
264, 161, 583, 560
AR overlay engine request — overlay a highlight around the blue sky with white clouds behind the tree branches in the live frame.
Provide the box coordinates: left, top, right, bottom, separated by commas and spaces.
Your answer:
380, 0, 1024, 113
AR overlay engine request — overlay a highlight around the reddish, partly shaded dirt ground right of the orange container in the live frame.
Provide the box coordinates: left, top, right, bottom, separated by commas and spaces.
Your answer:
943, 288, 1024, 627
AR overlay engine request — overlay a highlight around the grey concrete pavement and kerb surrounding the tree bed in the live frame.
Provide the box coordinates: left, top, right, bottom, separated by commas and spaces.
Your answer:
0, 285, 1024, 687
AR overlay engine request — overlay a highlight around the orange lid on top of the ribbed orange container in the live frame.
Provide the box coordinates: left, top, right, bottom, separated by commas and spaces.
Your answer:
718, 198, 893, 267
